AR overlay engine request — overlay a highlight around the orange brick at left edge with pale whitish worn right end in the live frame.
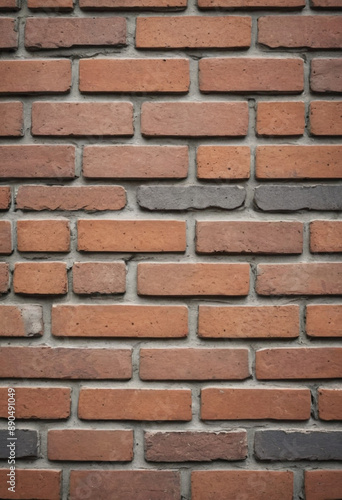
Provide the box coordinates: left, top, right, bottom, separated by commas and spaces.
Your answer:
0, 305, 44, 337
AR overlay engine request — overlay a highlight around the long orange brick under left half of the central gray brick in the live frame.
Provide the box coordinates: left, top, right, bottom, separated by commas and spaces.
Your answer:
78, 219, 186, 252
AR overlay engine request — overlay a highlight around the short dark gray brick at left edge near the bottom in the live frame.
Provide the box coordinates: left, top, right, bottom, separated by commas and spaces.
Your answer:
0, 429, 38, 460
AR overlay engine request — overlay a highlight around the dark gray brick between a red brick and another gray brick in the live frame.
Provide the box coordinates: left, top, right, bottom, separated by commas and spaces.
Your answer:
138, 186, 246, 210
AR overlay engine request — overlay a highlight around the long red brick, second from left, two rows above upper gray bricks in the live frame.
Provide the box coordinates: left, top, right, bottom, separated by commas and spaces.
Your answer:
32, 101, 134, 137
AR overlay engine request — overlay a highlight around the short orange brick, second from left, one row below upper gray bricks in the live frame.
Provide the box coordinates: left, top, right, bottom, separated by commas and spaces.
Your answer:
17, 219, 70, 252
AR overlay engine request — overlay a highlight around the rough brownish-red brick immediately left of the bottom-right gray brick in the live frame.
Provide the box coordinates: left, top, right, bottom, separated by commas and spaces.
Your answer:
144, 430, 247, 462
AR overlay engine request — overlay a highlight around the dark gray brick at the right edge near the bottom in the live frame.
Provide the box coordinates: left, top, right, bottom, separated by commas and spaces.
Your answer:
254, 430, 342, 461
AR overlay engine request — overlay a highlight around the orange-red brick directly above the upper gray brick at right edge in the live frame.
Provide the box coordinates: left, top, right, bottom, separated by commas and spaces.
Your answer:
256, 145, 342, 180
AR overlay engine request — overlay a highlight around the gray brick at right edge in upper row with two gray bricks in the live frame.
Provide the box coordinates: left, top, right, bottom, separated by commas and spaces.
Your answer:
254, 184, 342, 212
